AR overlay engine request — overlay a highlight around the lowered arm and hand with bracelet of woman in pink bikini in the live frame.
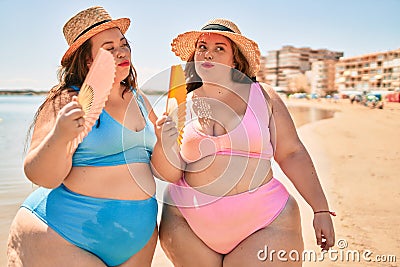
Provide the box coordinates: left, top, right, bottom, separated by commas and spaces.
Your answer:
265, 84, 335, 249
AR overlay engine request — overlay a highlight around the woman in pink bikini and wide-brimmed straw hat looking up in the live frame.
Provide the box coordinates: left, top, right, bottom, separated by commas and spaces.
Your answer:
159, 19, 335, 266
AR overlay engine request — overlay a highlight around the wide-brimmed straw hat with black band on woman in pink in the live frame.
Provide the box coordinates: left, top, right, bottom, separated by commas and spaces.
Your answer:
171, 19, 260, 77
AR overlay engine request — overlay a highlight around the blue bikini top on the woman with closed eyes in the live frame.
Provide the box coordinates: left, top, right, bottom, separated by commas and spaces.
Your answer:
71, 86, 156, 166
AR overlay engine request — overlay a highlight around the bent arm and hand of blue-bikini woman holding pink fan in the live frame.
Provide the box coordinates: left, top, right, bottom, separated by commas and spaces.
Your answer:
24, 93, 84, 188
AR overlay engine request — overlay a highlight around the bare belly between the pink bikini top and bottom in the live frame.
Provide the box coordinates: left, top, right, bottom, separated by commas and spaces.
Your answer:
185, 155, 273, 196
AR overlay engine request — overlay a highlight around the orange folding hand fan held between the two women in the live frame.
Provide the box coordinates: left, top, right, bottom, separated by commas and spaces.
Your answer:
166, 65, 187, 144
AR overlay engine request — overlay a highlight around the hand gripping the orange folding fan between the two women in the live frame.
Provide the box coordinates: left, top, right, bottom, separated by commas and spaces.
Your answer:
155, 113, 178, 149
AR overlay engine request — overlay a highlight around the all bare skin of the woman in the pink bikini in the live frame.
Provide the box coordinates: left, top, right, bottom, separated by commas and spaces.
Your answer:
160, 33, 334, 267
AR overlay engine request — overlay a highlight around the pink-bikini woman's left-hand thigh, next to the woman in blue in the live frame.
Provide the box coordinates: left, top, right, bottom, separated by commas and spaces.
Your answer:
160, 191, 223, 267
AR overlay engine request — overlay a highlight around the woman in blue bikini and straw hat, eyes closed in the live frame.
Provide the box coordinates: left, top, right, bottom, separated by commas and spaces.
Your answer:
8, 7, 177, 267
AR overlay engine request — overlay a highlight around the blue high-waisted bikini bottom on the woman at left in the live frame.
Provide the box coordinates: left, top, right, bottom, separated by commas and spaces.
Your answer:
22, 185, 158, 266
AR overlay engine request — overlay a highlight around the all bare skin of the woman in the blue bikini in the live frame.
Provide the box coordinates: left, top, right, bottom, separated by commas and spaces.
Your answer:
8, 28, 180, 267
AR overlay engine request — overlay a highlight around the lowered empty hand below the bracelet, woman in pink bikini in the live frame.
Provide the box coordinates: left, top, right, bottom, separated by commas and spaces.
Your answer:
313, 212, 335, 250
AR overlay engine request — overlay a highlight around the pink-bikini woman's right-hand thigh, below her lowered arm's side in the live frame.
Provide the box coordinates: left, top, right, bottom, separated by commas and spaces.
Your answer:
223, 196, 303, 267
